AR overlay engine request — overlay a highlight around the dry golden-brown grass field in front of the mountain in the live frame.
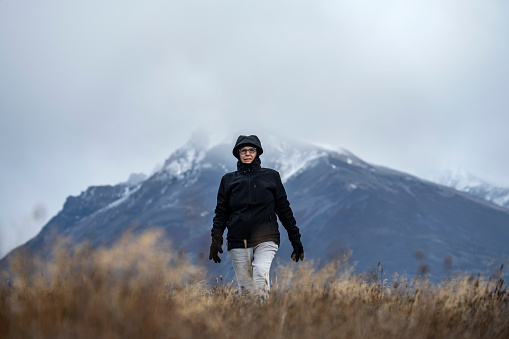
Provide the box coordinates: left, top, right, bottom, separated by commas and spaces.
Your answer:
0, 231, 509, 339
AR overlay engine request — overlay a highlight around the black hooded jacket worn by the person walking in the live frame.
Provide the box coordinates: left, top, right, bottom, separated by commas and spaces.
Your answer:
211, 138, 300, 250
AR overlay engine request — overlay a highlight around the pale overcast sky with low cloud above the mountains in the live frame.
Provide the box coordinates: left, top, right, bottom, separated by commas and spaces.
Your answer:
0, 0, 509, 255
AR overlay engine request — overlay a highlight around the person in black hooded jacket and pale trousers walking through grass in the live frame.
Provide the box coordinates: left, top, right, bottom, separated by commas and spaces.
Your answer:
209, 135, 304, 298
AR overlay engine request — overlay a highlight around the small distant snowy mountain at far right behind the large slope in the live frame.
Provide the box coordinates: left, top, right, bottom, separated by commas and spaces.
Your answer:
432, 169, 509, 209
